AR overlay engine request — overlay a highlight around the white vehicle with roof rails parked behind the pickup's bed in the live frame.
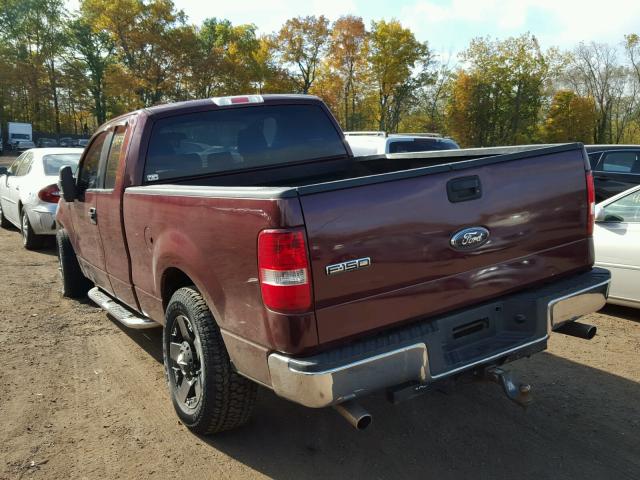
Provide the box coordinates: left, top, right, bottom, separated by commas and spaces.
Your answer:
344, 132, 460, 157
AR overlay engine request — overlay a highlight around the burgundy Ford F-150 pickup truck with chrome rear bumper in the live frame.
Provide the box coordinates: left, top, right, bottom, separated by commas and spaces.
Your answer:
57, 95, 609, 434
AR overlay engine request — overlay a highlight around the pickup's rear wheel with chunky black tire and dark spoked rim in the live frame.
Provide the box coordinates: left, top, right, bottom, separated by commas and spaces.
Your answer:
162, 287, 257, 435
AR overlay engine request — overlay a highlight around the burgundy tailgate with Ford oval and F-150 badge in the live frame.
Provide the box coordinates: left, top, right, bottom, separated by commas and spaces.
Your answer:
300, 148, 593, 343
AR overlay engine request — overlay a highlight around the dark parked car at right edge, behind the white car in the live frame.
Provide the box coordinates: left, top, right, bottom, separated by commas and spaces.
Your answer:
585, 145, 640, 202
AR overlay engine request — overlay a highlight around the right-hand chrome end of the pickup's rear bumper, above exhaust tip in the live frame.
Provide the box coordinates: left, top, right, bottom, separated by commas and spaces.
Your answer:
547, 279, 611, 332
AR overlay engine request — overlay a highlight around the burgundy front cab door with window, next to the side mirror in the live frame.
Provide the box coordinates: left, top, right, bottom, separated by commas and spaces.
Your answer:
70, 132, 112, 293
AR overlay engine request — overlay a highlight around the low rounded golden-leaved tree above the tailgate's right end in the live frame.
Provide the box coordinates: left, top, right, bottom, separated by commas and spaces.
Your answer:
543, 90, 597, 143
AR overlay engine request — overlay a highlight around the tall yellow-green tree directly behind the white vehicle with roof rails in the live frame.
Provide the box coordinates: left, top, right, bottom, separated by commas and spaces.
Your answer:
368, 20, 432, 132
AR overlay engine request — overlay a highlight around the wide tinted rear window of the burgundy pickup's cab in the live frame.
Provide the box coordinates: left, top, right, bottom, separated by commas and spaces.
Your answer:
144, 105, 347, 182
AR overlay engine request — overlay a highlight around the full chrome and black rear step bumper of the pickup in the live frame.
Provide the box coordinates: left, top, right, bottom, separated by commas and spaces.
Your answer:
268, 268, 610, 408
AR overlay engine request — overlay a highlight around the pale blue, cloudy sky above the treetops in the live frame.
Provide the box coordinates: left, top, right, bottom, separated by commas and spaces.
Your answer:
69, 0, 640, 56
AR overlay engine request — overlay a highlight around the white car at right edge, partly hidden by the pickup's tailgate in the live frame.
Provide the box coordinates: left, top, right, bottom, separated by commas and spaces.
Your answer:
593, 185, 640, 308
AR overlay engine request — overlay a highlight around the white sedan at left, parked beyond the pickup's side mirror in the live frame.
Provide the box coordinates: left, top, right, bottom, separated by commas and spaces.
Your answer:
0, 148, 83, 250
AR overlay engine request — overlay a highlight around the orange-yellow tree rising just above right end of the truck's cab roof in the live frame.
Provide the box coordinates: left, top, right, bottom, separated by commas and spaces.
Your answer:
276, 15, 329, 93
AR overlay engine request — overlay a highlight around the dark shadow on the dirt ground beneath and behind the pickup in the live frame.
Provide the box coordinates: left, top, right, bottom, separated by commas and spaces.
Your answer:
115, 318, 640, 479
